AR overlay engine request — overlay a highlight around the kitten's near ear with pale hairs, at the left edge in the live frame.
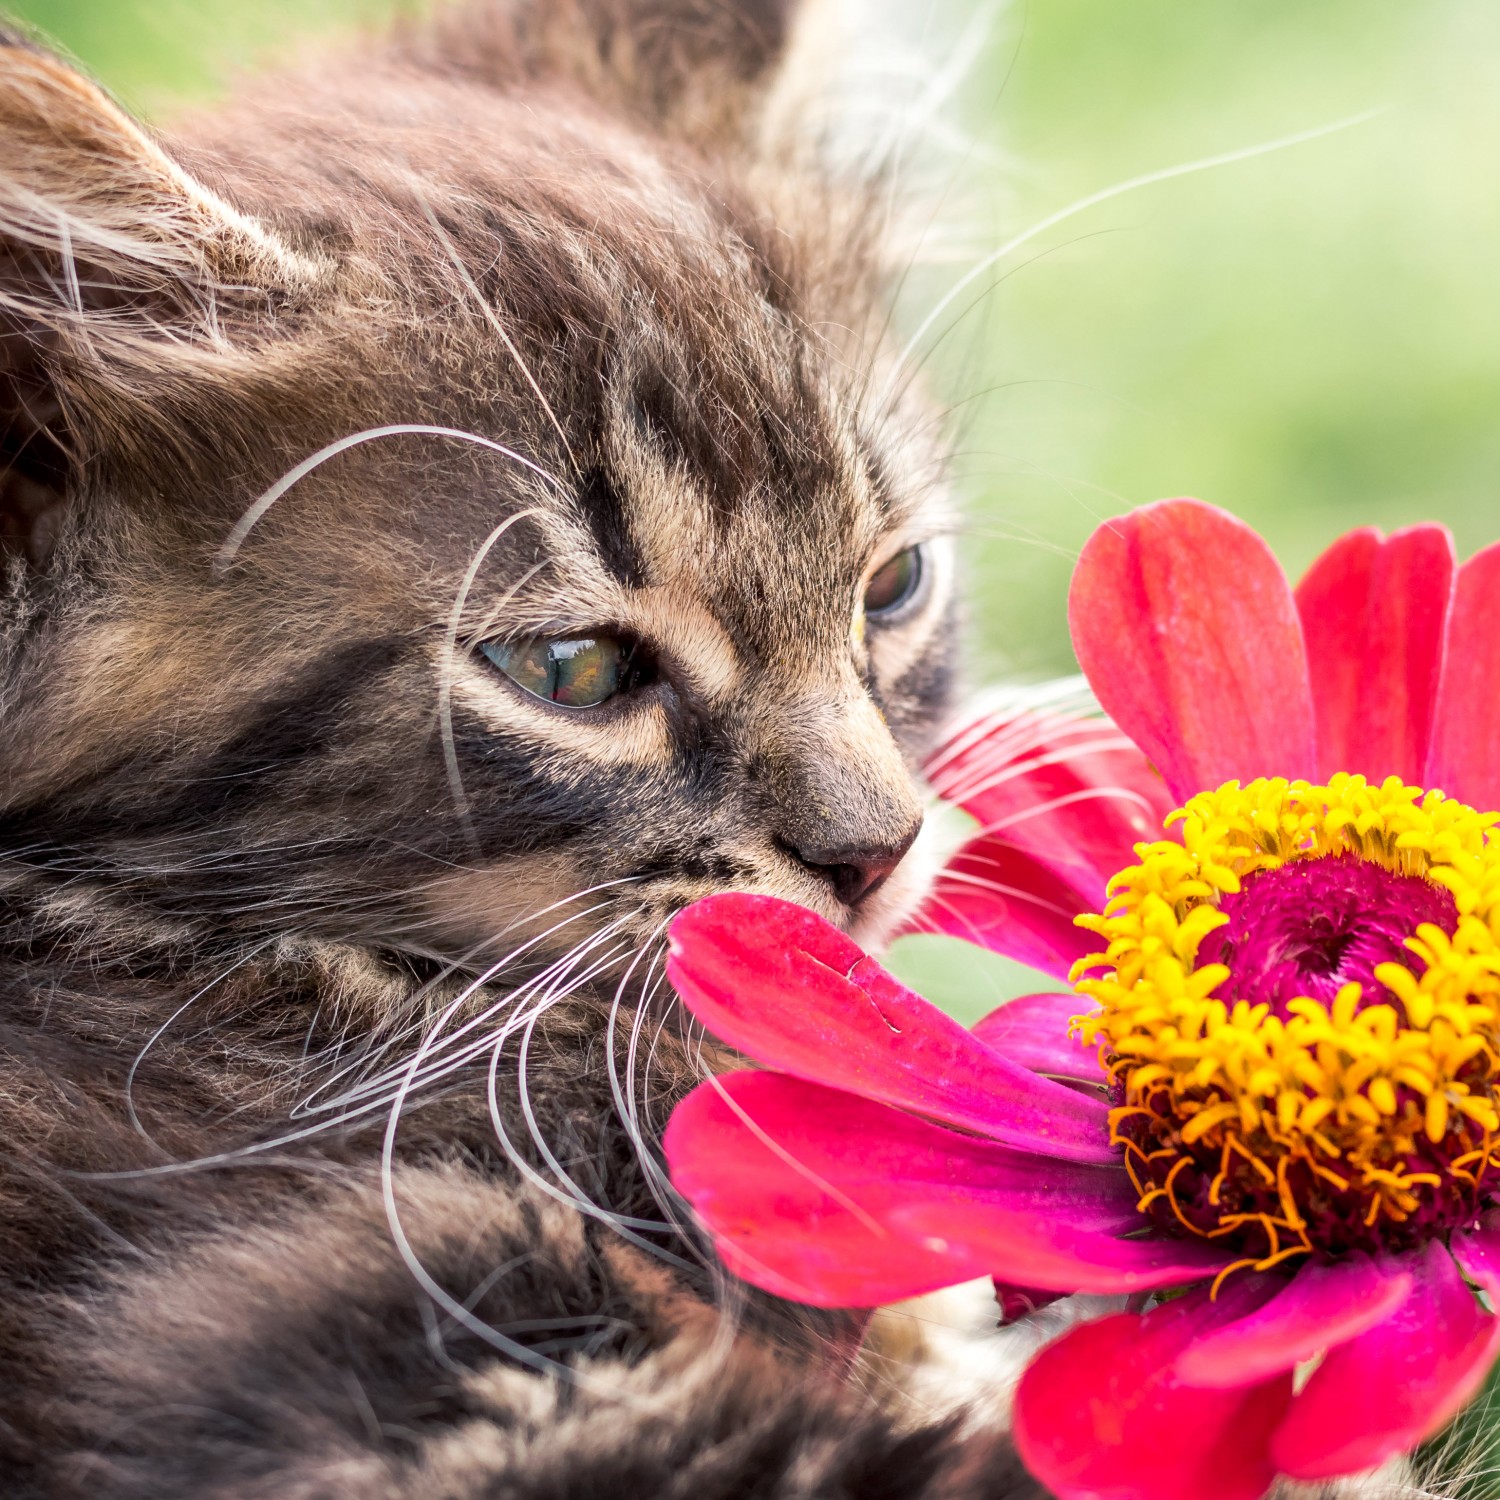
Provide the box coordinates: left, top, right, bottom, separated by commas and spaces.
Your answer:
0, 29, 309, 564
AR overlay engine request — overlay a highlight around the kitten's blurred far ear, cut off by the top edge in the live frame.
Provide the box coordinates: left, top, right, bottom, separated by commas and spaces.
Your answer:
429, 0, 797, 146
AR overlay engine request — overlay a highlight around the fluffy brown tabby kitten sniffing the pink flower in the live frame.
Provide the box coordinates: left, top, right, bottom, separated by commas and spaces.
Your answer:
0, 0, 1032, 1500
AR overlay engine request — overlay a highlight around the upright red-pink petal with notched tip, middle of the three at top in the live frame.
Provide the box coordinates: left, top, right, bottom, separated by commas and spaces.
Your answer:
1296, 525, 1455, 785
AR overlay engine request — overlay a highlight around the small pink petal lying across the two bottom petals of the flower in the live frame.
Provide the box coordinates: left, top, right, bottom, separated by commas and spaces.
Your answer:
1178, 1254, 1412, 1391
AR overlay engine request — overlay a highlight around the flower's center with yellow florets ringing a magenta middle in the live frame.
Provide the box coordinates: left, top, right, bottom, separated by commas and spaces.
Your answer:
1074, 776, 1500, 1266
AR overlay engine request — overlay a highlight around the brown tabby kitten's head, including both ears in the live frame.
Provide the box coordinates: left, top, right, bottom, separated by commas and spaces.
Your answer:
0, 0, 953, 978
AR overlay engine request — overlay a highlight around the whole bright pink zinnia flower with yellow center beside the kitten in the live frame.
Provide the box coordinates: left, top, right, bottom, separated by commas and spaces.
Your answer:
666, 501, 1500, 1500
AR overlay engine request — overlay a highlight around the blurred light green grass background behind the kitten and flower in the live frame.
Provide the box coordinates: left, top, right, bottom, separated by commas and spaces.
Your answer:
11, 0, 1500, 1496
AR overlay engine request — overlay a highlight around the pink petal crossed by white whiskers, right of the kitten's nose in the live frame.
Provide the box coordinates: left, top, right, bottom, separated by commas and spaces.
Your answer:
926, 713, 1173, 911
